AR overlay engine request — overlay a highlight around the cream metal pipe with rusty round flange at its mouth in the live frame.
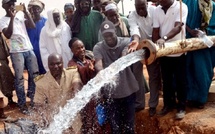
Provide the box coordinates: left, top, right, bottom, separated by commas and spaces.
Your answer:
138, 36, 215, 64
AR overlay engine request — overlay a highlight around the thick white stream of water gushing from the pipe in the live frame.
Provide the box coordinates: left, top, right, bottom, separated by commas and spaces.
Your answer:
38, 49, 145, 134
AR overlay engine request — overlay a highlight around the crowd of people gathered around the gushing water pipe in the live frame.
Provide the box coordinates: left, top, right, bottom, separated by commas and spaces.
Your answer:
0, 0, 215, 134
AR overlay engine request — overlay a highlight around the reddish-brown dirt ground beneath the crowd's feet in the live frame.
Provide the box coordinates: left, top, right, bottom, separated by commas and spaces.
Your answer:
0, 67, 215, 134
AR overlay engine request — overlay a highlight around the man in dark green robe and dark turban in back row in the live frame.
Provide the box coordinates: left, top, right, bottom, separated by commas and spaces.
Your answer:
71, 0, 103, 51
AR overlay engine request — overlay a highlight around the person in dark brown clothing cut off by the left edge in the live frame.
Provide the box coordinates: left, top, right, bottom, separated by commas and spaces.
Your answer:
0, 33, 16, 106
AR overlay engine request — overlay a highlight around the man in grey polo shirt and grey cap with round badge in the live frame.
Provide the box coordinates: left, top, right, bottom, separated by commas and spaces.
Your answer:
93, 21, 139, 134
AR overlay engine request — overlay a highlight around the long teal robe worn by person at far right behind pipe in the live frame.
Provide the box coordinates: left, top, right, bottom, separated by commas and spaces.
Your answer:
183, 0, 215, 103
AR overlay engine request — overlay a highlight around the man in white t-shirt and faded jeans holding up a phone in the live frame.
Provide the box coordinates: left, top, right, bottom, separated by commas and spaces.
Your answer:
0, 0, 38, 114
